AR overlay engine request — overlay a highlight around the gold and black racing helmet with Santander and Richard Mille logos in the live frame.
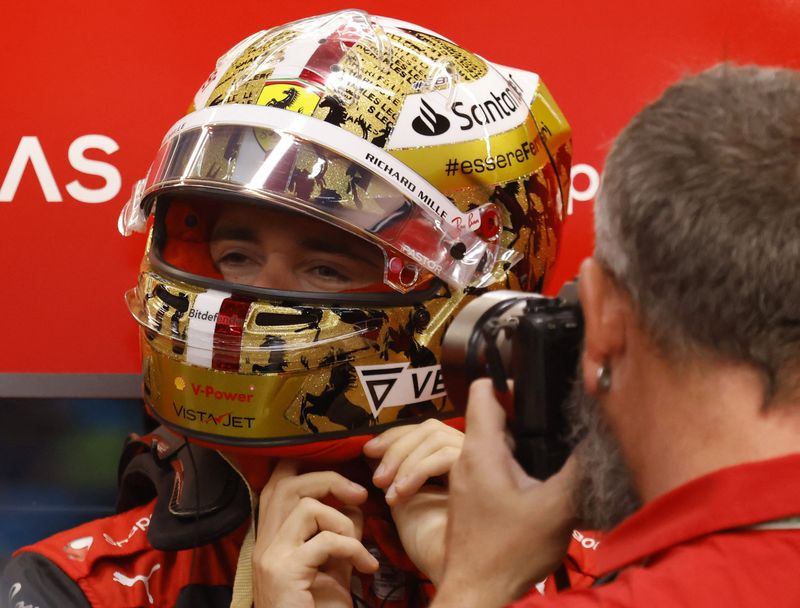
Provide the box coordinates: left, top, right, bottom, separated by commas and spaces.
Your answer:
120, 10, 571, 453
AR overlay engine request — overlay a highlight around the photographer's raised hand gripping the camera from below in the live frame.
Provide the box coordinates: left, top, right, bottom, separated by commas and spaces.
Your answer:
433, 379, 575, 608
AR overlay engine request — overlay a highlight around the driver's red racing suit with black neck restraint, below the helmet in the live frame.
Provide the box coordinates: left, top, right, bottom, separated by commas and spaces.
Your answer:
0, 429, 433, 608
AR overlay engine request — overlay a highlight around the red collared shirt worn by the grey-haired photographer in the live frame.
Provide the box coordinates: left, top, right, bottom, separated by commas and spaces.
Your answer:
513, 454, 800, 608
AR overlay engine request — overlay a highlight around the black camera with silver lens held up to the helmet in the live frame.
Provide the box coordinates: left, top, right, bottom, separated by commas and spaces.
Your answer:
442, 281, 583, 479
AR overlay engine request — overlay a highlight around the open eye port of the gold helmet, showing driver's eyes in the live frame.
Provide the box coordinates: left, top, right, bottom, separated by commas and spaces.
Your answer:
153, 191, 404, 293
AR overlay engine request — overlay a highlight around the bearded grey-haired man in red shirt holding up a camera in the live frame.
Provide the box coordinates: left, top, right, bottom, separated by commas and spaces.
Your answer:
434, 65, 800, 608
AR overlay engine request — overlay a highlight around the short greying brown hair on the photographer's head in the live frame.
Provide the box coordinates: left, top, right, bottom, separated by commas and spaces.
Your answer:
595, 64, 800, 402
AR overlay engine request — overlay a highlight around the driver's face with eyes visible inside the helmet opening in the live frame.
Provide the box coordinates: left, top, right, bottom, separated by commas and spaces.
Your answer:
209, 207, 384, 292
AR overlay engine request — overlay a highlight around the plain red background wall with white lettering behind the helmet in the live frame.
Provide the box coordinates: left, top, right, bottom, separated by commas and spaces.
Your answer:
0, 0, 800, 373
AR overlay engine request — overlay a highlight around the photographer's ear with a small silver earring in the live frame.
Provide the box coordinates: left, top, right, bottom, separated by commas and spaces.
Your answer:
578, 258, 628, 394
